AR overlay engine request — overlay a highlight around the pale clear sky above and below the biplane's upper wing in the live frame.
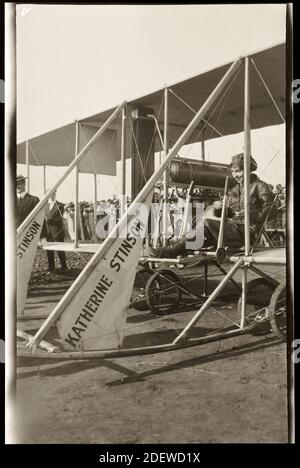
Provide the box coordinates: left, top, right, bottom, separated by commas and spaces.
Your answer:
17, 4, 285, 201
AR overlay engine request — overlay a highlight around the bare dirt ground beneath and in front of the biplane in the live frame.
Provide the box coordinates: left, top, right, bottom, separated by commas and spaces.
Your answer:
17, 249, 288, 444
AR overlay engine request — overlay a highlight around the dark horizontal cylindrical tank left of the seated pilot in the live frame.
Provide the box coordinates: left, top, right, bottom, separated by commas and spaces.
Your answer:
169, 159, 235, 188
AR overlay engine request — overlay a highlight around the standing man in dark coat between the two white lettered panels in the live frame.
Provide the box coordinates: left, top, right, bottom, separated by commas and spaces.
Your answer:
41, 188, 67, 271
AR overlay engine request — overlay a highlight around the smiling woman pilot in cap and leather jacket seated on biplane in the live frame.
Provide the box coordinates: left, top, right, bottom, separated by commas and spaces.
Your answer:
204, 153, 277, 248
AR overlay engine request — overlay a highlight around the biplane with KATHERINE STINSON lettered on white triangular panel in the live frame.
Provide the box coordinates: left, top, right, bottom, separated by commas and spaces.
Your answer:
17, 44, 287, 359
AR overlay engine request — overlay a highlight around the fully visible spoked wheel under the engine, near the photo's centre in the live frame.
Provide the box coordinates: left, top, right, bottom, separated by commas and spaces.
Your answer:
145, 269, 182, 315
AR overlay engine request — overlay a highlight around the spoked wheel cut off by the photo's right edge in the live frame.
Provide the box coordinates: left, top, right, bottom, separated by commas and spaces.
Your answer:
269, 284, 286, 340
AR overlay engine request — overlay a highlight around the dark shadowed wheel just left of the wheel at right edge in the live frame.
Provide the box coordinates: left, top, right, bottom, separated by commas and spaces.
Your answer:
238, 278, 276, 334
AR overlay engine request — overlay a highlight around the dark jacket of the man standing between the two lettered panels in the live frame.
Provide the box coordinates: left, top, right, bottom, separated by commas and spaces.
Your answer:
41, 201, 64, 242
